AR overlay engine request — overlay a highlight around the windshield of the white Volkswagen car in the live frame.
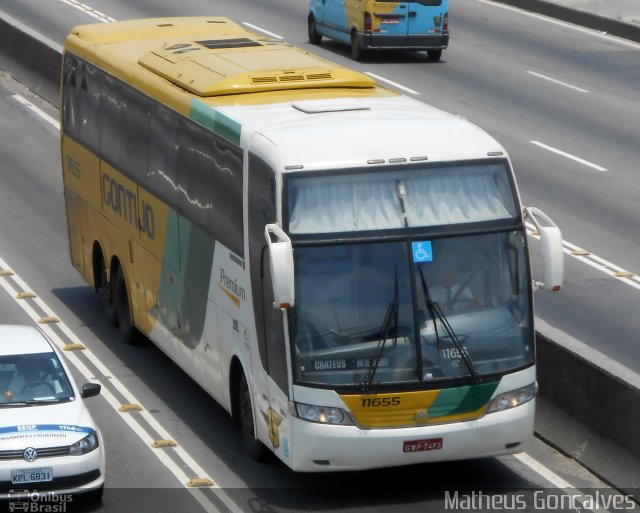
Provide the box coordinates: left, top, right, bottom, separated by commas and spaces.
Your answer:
0, 352, 74, 406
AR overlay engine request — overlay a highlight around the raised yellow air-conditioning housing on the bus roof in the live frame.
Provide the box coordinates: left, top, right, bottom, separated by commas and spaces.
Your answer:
139, 37, 375, 97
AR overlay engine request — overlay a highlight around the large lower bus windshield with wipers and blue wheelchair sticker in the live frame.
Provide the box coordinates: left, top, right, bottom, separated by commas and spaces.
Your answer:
292, 231, 534, 386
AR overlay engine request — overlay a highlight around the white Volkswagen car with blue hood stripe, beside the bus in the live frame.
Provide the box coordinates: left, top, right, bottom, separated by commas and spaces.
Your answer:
0, 325, 105, 501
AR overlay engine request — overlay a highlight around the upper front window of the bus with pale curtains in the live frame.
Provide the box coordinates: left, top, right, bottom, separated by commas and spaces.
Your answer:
287, 160, 516, 235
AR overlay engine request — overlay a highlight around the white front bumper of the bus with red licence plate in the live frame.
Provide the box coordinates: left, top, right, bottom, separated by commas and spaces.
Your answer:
288, 399, 535, 472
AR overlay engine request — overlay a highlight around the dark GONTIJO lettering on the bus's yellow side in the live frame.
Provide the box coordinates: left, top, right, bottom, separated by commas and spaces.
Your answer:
102, 173, 156, 240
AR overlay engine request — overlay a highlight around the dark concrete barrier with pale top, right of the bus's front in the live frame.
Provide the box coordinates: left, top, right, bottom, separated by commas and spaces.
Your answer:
536, 319, 640, 492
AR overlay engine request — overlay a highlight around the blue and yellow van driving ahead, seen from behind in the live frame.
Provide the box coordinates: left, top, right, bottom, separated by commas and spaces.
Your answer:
308, 0, 449, 61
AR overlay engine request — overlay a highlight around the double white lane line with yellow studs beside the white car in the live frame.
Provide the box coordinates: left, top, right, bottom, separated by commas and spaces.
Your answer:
0, 257, 242, 513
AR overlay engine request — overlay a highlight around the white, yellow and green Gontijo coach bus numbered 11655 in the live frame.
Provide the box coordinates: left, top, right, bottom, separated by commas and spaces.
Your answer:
61, 17, 562, 471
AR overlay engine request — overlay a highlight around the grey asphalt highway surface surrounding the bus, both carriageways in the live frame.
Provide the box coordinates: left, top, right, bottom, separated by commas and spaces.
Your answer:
0, 0, 640, 511
